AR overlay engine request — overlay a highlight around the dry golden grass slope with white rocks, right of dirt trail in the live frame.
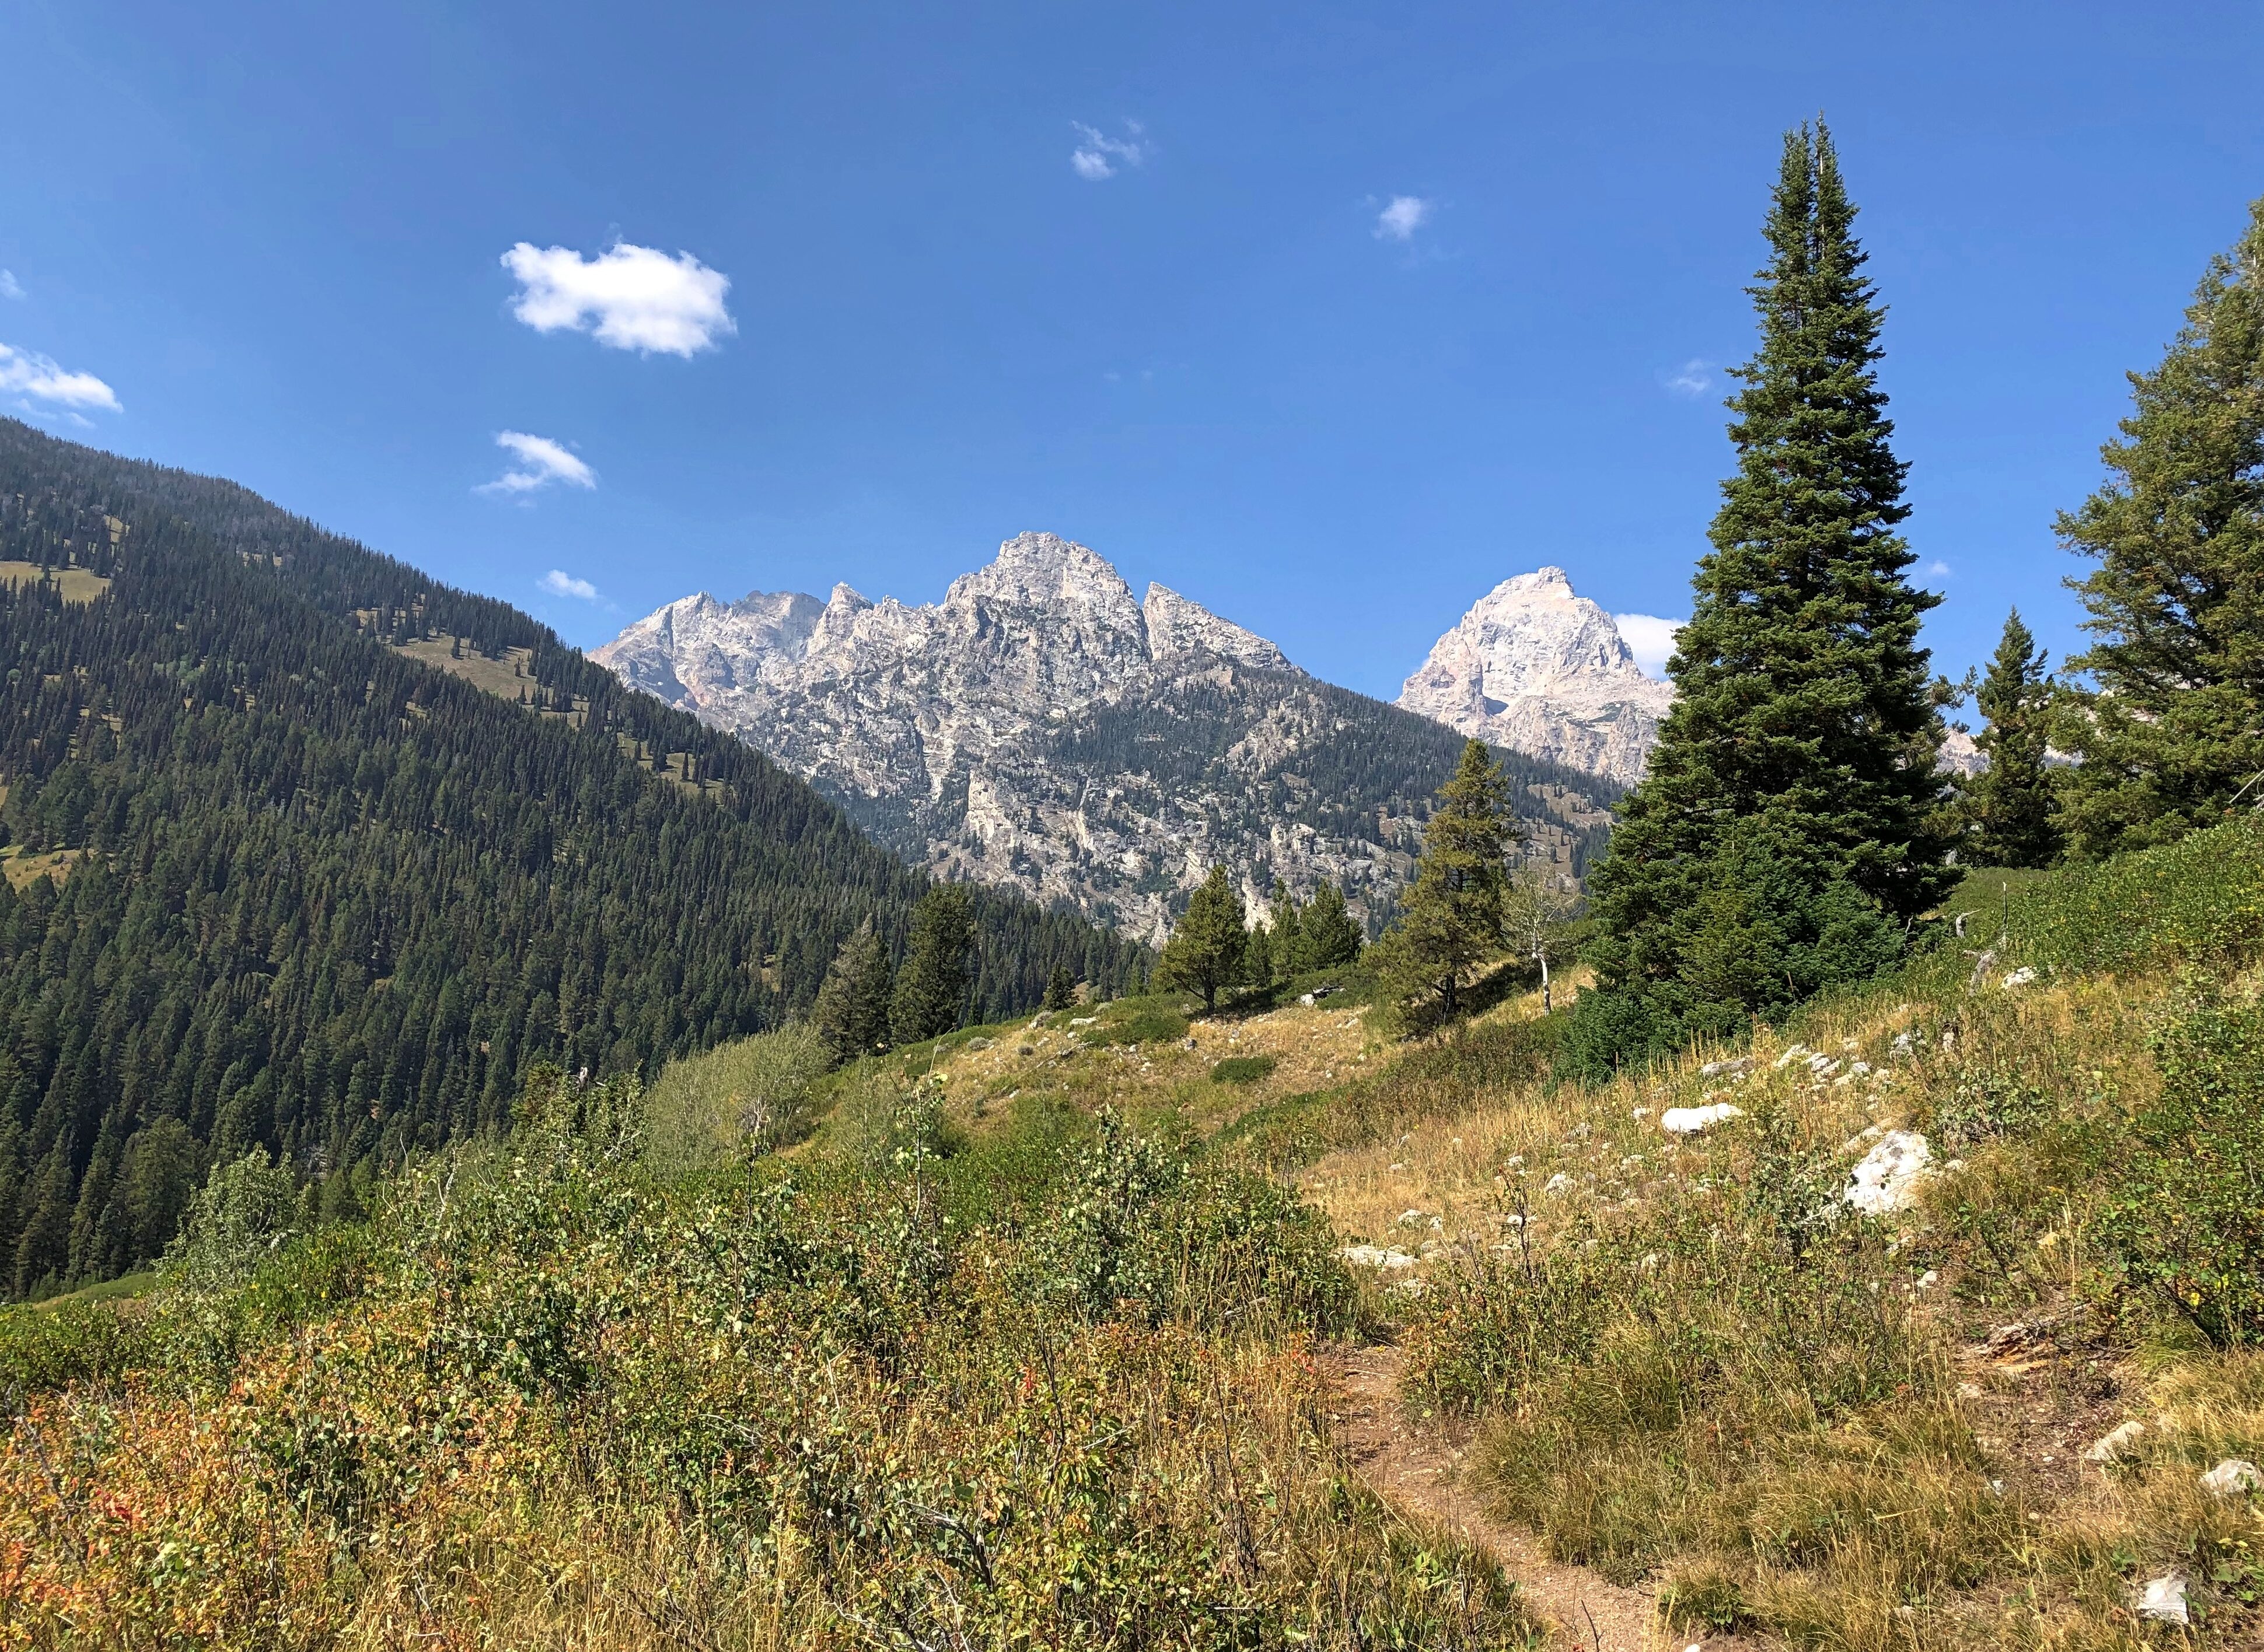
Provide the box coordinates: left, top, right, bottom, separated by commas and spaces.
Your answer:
1306, 821, 2264, 1650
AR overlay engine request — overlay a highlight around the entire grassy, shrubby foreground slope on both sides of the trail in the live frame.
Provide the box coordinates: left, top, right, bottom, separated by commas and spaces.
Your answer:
0, 821, 2264, 1652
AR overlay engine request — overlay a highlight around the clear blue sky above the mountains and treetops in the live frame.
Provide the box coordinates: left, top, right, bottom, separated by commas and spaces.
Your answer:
0, 0, 2264, 697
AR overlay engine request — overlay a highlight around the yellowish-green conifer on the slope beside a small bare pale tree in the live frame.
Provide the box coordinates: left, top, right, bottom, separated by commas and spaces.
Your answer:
1367, 740, 1521, 1032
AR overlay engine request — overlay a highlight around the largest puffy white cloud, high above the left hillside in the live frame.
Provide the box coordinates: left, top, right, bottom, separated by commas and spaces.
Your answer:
502, 240, 738, 355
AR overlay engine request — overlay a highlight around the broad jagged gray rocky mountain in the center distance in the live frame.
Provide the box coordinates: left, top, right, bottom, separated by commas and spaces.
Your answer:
593, 534, 1610, 939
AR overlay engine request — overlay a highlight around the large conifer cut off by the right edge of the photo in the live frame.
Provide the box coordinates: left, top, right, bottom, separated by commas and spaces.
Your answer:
2056, 199, 2264, 855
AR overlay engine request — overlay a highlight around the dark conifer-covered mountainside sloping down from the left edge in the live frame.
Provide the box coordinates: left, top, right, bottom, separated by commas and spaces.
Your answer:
0, 421, 1137, 1294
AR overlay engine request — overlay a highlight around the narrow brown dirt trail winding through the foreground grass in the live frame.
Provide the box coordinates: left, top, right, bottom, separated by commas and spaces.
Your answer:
1338, 1346, 1748, 1652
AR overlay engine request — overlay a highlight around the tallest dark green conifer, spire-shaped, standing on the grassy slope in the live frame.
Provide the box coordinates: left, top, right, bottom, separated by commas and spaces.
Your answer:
1582, 124, 1952, 1054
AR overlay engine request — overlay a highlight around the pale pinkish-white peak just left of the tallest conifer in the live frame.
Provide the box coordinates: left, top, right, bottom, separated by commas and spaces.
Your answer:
1397, 568, 1675, 785
